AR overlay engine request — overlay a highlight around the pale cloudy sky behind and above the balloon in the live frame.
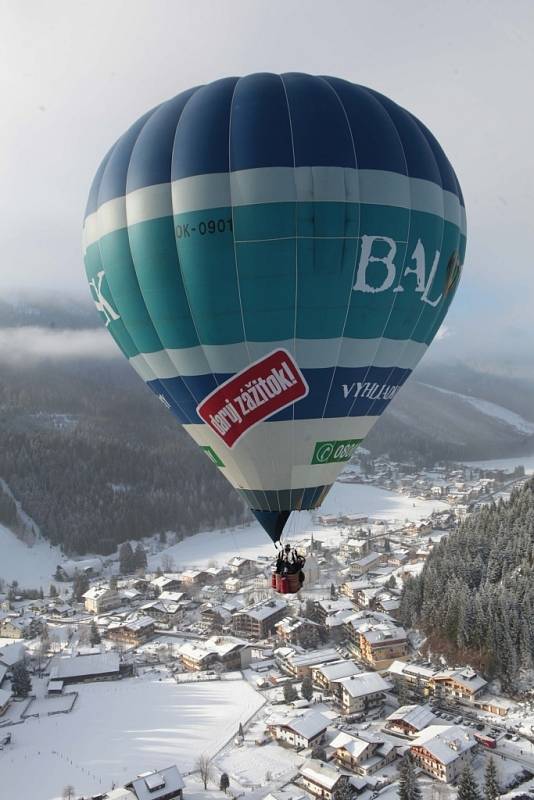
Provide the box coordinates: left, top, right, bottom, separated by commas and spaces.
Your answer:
0, 0, 534, 360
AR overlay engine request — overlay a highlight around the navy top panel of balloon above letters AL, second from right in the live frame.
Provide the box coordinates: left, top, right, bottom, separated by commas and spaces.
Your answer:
368, 89, 441, 186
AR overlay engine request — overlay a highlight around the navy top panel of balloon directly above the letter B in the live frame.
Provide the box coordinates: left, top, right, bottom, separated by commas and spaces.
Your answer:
325, 76, 407, 175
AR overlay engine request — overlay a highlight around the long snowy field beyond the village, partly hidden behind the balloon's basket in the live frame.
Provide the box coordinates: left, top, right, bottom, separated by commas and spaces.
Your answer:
148, 483, 449, 569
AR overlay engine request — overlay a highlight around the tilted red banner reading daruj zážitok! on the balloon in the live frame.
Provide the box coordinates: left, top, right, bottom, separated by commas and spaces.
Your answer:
197, 350, 309, 447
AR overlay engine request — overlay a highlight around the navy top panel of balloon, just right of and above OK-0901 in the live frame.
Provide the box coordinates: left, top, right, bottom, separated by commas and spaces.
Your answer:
230, 73, 293, 171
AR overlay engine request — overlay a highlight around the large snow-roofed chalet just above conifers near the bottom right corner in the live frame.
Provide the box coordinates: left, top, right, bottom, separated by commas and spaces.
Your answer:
410, 725, 476, 783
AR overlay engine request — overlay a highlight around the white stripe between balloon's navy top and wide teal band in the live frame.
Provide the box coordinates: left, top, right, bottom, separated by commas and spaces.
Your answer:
84, 167, 466, 248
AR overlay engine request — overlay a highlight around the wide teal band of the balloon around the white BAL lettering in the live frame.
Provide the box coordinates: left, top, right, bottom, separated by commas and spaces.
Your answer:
93, 202, 465, 352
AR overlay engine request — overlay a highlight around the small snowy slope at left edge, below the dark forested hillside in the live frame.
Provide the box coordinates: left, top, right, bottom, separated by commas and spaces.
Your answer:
0, 525, 63, 589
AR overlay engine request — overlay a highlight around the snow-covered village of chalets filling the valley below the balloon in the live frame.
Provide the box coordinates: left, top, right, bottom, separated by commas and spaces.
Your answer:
0, 454, 534, 800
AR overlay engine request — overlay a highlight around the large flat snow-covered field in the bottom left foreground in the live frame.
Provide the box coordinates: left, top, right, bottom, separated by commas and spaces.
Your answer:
0, 678, 263, 800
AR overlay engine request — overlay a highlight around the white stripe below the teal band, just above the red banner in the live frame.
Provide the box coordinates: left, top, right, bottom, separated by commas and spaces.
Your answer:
130, 337, 428, 380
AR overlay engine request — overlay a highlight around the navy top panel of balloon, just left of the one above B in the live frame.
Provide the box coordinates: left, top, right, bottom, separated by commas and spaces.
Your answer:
282, 72, 355, 168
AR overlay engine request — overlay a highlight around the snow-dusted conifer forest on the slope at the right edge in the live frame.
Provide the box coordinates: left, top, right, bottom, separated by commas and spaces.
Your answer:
401, 479, 534, 692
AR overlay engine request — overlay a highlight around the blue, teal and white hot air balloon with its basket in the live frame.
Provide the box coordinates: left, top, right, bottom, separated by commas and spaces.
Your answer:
83, 73, 466, 591
